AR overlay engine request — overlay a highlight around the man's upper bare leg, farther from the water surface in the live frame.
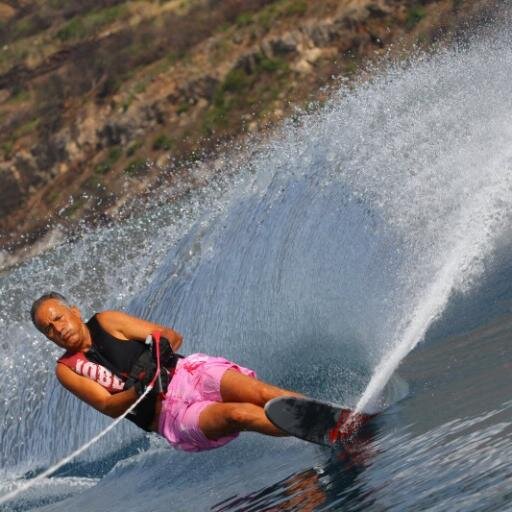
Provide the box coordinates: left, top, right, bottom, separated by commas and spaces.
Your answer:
220, 370, 303, 407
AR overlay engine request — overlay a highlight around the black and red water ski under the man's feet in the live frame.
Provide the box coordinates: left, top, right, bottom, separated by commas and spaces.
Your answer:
265, 396, 372, 446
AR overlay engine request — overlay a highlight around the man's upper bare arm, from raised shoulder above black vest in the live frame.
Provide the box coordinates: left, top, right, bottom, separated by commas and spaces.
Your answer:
97, 311, 183, 351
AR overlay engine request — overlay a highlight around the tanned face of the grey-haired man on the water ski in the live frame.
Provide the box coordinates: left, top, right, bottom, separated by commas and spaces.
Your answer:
35, 299, 86, 351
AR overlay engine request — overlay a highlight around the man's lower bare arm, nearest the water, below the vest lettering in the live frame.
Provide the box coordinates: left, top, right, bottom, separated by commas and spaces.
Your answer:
55, 364, 137, 418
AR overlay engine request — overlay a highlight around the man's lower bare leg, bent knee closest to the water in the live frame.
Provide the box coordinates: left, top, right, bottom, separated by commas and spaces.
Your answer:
199, 402, 287, 440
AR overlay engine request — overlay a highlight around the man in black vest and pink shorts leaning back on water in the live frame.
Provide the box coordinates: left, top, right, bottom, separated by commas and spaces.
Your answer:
31, 292, 300, 451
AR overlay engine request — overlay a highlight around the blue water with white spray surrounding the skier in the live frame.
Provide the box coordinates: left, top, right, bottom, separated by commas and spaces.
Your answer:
0, 20, 512, 512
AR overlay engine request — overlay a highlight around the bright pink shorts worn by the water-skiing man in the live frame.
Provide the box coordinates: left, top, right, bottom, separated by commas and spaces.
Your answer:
158, 354, 256, 452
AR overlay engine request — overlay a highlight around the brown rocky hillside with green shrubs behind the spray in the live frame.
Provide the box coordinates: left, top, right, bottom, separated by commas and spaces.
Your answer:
0, 0, 494, 258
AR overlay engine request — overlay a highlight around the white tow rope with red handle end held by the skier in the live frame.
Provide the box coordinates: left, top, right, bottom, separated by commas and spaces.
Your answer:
0, 331, 162, 505
